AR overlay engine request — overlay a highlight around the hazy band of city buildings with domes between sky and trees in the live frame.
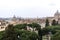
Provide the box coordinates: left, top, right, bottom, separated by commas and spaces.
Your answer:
0, 10, 60, 31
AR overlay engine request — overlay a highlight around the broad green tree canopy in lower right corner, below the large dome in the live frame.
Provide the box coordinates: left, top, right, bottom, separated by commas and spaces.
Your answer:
43, 25, 60, 40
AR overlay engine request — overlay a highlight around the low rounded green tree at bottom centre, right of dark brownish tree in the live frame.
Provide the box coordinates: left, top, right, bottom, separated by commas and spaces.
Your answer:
16, 30, 38, 40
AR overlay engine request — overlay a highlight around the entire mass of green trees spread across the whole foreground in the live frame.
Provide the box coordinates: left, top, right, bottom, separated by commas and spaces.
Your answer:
0, 23, 60, 40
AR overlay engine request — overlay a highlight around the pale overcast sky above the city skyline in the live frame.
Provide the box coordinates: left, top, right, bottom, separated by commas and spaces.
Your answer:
0, 0, 60, 17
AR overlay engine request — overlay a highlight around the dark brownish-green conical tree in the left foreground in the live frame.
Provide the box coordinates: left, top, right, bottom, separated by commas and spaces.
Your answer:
2, 25, 17, 40
